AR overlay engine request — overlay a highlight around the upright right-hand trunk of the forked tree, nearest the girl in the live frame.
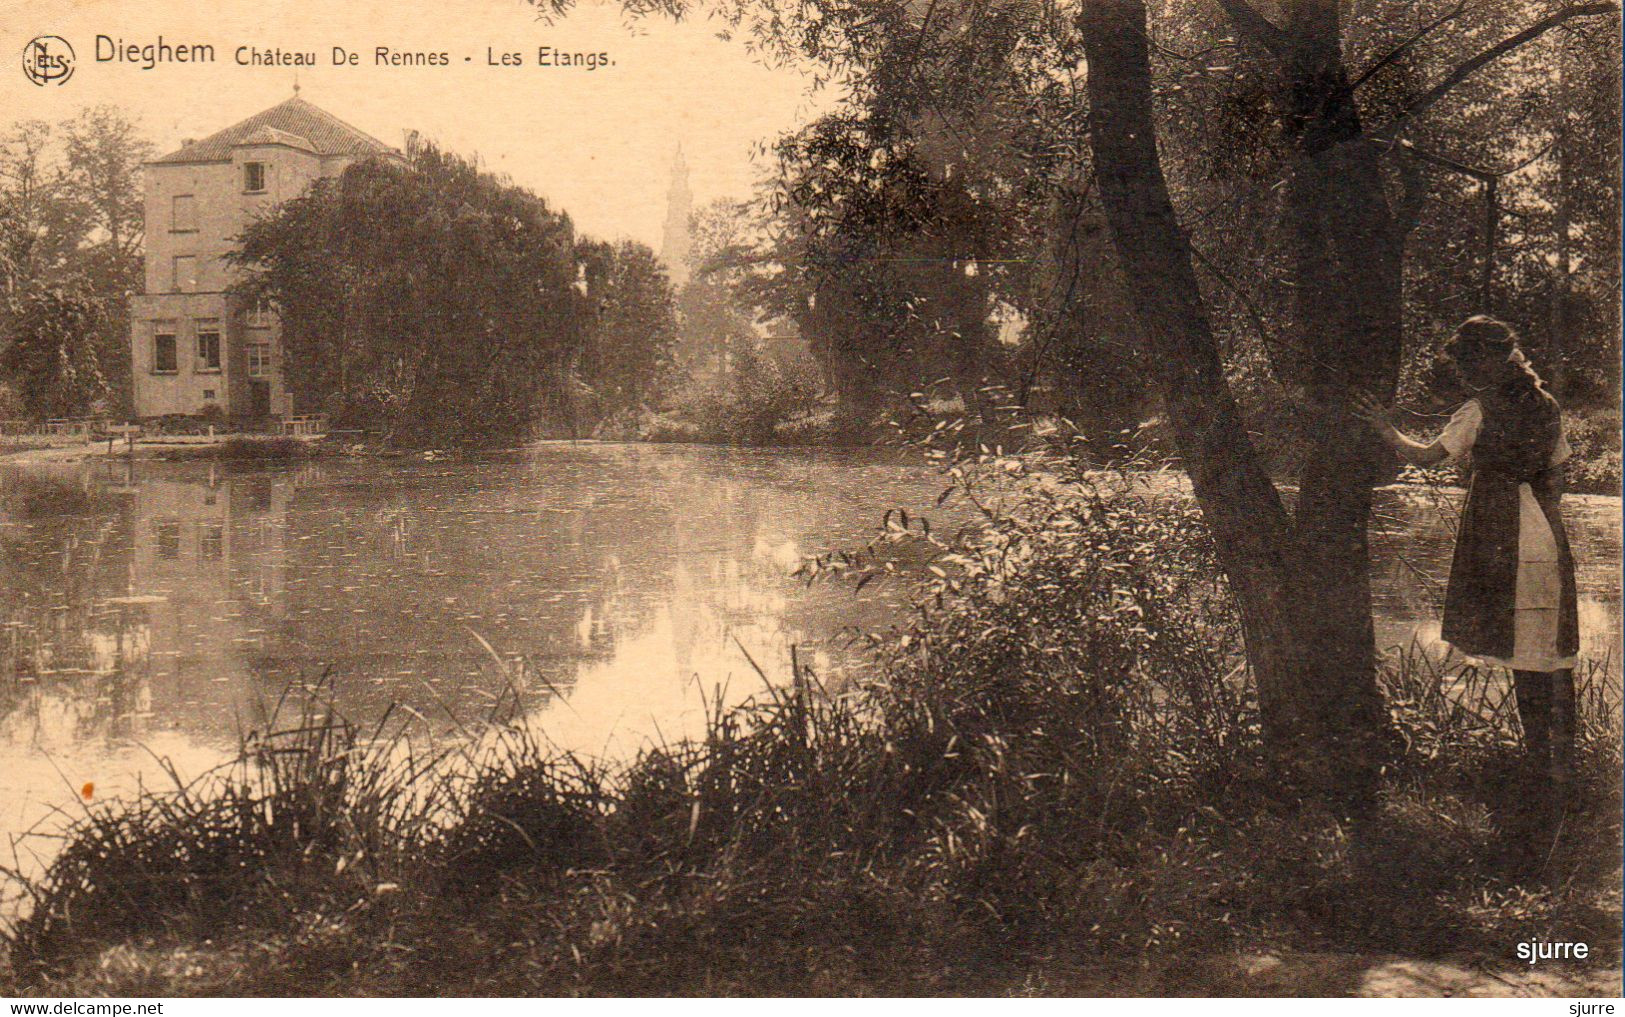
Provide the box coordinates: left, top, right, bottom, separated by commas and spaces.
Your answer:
1282, 15, 1404, 768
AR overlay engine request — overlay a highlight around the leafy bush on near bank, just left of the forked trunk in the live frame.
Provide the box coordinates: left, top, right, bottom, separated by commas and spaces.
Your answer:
882, 461, 1258, 942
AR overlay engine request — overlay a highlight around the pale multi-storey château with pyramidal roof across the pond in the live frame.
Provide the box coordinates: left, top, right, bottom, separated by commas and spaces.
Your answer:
130, 93, 398, 422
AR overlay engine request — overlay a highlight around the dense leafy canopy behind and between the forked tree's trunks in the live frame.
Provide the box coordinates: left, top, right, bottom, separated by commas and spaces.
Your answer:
594, 0, 1619, 465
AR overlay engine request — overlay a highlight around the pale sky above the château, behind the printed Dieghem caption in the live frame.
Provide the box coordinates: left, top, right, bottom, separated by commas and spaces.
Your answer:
0, 0, 830, 250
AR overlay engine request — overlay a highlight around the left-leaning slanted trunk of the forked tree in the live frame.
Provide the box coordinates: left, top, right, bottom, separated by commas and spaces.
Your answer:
1079, 0, 1339, 786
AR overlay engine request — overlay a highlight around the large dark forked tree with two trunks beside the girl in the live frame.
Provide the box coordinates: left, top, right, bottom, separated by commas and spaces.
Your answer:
1079, 0, 1617, 783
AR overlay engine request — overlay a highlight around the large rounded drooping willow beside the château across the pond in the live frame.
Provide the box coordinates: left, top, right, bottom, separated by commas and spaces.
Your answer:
232, 145, 588, 447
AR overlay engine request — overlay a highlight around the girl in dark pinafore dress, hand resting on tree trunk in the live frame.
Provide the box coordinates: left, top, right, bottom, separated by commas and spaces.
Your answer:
1355, 315, 1580, 816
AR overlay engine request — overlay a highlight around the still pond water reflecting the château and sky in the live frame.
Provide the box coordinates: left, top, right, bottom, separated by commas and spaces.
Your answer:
0, 444, 1620, 857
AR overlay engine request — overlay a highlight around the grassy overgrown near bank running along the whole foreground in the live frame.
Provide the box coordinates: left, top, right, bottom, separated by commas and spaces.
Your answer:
7, 471, 1620, 994
